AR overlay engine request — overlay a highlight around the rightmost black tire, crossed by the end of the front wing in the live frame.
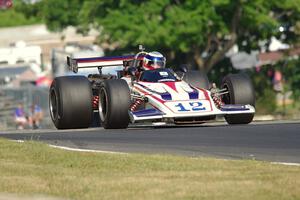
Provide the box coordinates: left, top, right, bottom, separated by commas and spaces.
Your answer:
221, 74, 255, 124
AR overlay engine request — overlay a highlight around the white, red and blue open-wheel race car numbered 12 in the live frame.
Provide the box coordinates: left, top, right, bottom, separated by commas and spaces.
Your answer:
49, 48, 255, 129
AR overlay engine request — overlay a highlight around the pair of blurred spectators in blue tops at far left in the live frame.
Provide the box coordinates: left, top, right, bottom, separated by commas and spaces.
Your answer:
14, 103, 43, 130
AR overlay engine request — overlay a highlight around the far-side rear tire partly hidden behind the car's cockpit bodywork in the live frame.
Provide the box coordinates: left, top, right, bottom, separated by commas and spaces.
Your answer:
176, 70, 209, 90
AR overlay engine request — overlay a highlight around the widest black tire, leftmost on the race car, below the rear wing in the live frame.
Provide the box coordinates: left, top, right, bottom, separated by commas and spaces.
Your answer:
49, 76, 93, 129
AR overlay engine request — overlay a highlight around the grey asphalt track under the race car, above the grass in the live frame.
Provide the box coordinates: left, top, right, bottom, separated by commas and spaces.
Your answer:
0, 122, 300, 163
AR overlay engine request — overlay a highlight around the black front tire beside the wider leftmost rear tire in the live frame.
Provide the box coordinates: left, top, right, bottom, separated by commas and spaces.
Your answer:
99, 79, 130, 129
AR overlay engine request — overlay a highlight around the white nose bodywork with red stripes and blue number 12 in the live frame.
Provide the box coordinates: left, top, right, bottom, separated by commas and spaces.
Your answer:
129, 81, 255, 122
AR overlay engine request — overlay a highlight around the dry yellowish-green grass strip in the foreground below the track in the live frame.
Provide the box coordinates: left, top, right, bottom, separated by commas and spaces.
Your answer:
0, 139, 300, 200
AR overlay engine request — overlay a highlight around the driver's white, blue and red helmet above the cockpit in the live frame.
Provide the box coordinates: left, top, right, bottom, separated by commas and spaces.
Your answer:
143, 51, 166, 70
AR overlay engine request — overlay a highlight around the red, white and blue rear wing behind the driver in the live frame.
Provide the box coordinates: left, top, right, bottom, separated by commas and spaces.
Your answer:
67, 55, 144, 73
